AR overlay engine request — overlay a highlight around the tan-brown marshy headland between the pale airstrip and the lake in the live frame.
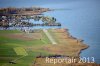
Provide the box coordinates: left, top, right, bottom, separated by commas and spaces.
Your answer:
42, 28, 89, 57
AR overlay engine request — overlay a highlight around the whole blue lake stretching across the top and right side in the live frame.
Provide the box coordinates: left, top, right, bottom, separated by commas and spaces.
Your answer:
0, 0, 100, 64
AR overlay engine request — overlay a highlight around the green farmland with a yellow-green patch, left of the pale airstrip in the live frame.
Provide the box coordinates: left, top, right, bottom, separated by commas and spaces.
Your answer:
0, 30, 50, 66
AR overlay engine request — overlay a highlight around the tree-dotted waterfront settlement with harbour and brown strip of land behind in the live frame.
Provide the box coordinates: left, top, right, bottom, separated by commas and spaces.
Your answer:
0, 7, 61, 29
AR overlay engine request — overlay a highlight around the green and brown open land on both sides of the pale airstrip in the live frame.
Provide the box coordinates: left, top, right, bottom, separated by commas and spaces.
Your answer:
0, 29, 87, 66
